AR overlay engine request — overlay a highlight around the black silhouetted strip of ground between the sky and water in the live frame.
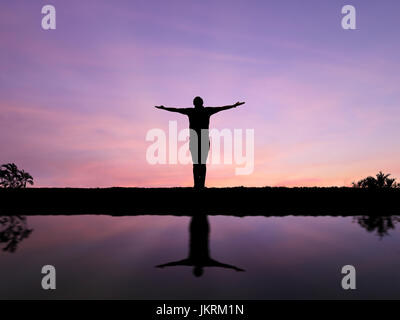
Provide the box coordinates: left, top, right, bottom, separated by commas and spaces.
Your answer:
0, 187, 400, 217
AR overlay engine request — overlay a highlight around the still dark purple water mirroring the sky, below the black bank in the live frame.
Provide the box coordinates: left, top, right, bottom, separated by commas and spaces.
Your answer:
0, 215, 400, 299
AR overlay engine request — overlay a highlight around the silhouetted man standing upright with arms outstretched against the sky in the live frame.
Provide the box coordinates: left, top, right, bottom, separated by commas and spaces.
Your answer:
156, 97, 244, 188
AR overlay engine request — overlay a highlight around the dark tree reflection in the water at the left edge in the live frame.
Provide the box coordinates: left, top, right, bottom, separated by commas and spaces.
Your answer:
0, 216, 33, 252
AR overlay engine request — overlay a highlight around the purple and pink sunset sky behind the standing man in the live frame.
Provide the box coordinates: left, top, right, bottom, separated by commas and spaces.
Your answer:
0, 0, 400, 187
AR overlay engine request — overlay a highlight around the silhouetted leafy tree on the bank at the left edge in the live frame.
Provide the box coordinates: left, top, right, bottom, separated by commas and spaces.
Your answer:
0, 163, 33, 188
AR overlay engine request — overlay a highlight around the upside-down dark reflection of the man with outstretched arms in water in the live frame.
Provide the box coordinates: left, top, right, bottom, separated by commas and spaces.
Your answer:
157, 215, 244, 277
